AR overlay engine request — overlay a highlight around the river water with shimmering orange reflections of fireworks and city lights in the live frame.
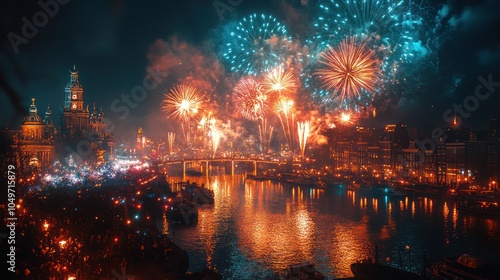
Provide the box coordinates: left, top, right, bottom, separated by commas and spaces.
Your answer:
163, 176, 500, 279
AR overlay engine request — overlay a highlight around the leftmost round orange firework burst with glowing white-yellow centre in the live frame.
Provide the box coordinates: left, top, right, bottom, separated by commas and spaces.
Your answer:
162, 85, 203, 122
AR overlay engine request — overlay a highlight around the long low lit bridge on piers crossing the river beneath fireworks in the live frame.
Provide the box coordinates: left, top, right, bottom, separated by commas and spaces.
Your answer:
158, 157, 290, 177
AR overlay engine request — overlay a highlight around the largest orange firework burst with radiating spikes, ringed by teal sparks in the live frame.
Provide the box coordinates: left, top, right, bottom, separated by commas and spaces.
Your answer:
315, 38, 380, 101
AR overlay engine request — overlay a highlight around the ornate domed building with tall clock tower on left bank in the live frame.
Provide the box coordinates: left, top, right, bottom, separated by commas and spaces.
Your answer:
10, 67, 115, 171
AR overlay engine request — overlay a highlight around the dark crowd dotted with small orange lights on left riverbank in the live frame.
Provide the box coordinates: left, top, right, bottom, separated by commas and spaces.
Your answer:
6, 173, 196, 280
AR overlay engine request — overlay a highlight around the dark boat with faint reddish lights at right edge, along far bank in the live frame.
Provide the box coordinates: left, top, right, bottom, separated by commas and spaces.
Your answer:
457, 196, 500, 216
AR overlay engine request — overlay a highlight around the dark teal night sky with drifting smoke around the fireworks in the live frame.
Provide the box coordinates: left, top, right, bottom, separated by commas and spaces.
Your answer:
0, 0, 500, 142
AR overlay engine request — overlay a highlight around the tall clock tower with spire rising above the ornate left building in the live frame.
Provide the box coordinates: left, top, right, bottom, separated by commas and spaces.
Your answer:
60, 66, 89, 140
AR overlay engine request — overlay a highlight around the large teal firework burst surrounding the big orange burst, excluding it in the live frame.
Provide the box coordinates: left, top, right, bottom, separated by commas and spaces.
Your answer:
301, 0, 441, 111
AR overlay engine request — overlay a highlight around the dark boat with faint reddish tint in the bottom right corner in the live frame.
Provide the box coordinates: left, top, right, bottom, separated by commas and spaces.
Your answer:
426, 254, 500, 280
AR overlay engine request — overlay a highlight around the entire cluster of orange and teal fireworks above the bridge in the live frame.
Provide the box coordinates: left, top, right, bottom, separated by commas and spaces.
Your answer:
152, 0, 444, 155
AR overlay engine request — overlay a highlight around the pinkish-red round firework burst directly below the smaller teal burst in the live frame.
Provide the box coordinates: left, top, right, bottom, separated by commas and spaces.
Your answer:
233, 78, 267, 121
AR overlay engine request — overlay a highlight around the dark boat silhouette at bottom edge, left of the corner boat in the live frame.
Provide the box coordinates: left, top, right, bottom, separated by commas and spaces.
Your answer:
351, 259, 422, 280
